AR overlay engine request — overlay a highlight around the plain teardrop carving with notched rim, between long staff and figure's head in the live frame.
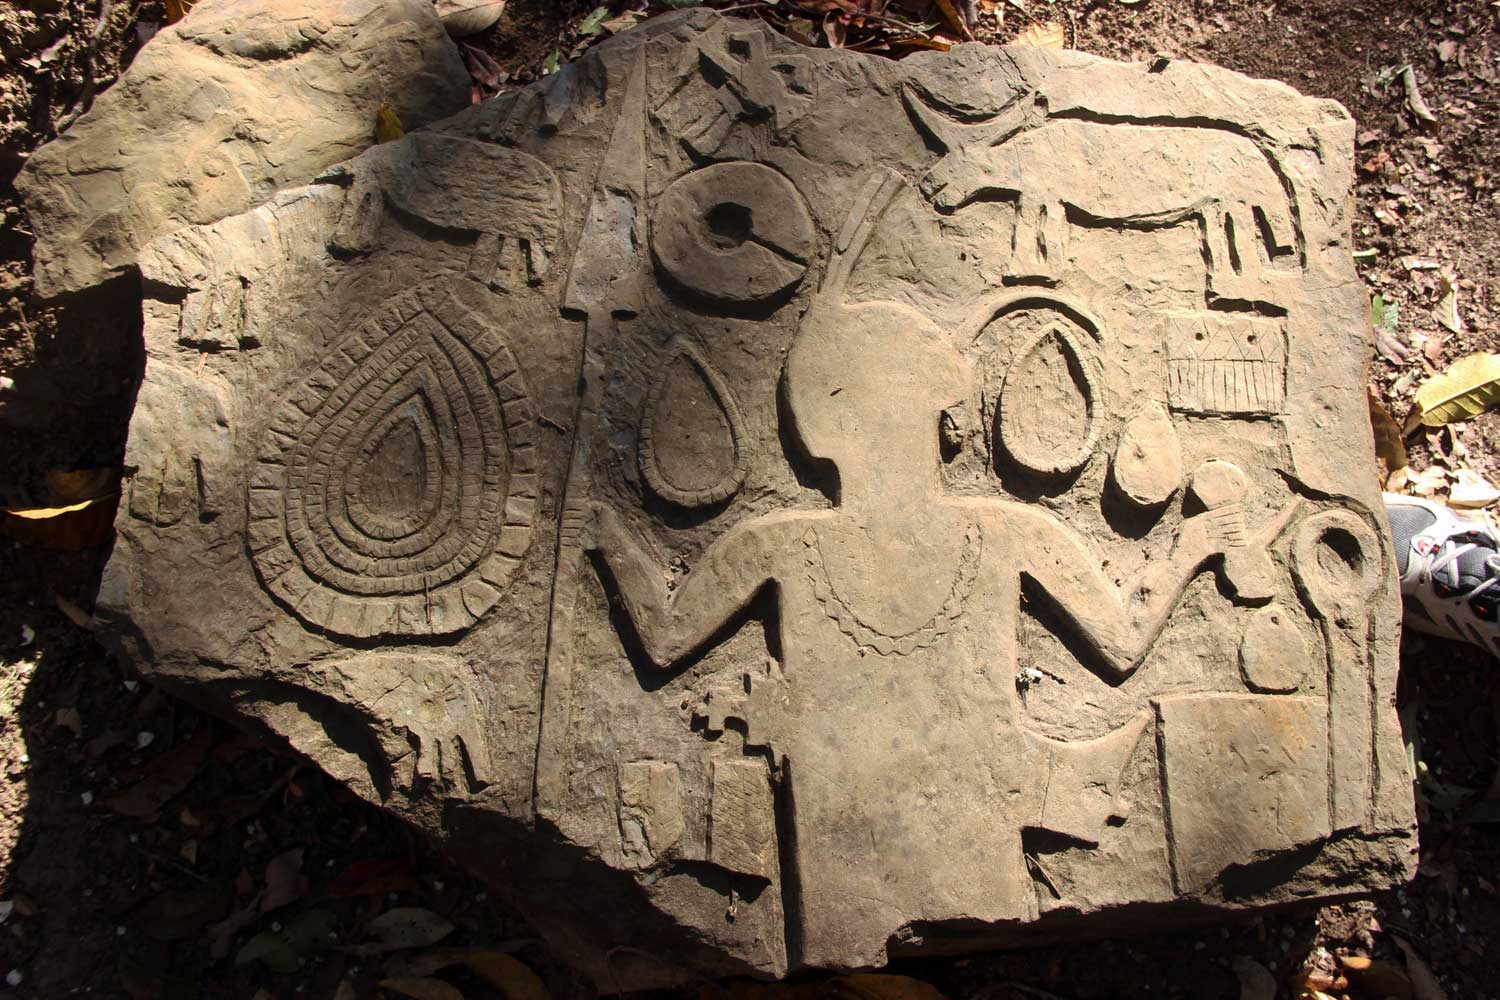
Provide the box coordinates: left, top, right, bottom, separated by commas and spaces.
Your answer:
638, 340, 746, 507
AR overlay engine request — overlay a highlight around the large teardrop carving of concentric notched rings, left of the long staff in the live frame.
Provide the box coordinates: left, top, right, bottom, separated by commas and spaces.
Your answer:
249, 289, 537, 637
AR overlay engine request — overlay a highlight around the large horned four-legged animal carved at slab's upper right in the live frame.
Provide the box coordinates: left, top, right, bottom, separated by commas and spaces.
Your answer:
906, 90, 1298, 298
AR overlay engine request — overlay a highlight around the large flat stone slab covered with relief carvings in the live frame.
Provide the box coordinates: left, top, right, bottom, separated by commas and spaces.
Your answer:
101, 12, 1415, 990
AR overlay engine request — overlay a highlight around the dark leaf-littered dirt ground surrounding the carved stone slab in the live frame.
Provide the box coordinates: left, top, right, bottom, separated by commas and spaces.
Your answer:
0, 0, 1500, 1000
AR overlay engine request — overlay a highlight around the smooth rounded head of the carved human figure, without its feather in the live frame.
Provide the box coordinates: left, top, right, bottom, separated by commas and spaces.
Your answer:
785, 301, 969, 474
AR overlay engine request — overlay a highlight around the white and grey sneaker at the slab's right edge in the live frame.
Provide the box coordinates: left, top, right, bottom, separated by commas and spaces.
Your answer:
1385, 493, 1500, 655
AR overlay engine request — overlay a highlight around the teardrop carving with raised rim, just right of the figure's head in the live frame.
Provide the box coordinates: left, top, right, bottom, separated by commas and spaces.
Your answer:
996, 324, 1100, 475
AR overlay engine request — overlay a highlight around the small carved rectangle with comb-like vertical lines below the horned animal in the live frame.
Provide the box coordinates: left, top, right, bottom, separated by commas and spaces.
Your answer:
1163, 313, 1287, 417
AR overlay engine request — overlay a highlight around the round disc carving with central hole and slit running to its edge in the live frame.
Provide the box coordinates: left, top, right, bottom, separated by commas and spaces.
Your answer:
651, 162, 815, 304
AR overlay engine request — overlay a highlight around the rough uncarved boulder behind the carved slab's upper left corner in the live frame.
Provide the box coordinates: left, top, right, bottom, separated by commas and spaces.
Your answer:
17, 0, 470, 297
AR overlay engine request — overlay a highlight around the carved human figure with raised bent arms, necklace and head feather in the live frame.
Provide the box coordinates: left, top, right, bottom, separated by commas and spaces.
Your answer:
590, 178, 1254, 966
